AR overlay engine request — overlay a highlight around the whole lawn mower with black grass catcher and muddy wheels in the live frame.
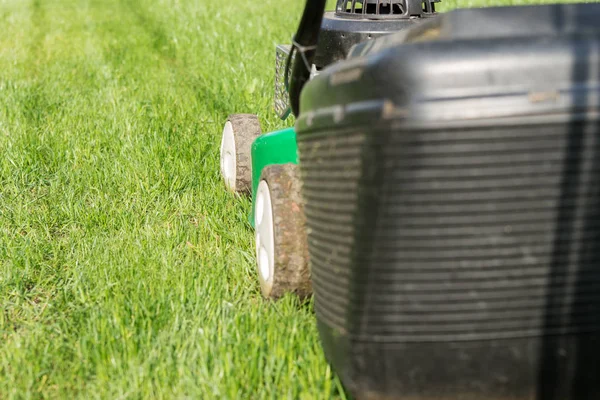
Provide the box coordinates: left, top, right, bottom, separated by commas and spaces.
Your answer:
221, 0, 600, 400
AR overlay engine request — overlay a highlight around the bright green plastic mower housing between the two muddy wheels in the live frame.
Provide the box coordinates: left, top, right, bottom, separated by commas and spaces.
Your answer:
250, 128, 298, 227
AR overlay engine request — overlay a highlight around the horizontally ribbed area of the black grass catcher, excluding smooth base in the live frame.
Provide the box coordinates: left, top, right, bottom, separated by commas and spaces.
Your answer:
300, 126, 600, 342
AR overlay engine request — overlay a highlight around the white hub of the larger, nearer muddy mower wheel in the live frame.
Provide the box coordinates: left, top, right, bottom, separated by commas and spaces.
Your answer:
254, 181, 275, 297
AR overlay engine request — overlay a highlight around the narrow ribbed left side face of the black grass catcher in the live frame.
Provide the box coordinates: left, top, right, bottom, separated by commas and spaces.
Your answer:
299, 134, 365, 330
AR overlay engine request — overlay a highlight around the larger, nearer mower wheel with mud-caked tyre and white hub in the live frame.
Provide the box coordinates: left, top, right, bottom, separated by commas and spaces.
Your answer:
254, 164, 312, 299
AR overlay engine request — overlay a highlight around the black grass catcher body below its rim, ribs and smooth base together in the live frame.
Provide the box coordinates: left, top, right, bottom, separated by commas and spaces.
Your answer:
299, 123, 600, 400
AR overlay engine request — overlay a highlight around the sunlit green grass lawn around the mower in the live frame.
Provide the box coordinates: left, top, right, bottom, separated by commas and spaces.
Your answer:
0, 0, 592, 399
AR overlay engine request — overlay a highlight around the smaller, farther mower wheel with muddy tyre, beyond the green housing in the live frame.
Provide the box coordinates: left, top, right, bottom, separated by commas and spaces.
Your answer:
221, 114, 261, 194
